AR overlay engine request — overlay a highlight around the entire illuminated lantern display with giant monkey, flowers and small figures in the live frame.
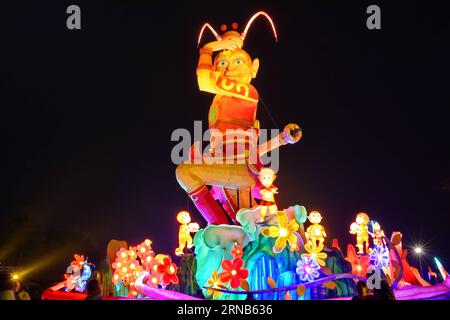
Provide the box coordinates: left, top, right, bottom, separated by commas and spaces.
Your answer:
43, 11, 450, 300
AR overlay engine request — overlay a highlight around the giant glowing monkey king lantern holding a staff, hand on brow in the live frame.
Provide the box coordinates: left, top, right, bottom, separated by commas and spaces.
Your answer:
176, 11, 301, 225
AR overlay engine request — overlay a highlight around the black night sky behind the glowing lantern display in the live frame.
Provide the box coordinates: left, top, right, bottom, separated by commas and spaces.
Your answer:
0, 1, 450, 290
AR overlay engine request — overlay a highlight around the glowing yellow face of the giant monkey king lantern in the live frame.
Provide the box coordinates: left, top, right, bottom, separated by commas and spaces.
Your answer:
214, 48, 259, 83
